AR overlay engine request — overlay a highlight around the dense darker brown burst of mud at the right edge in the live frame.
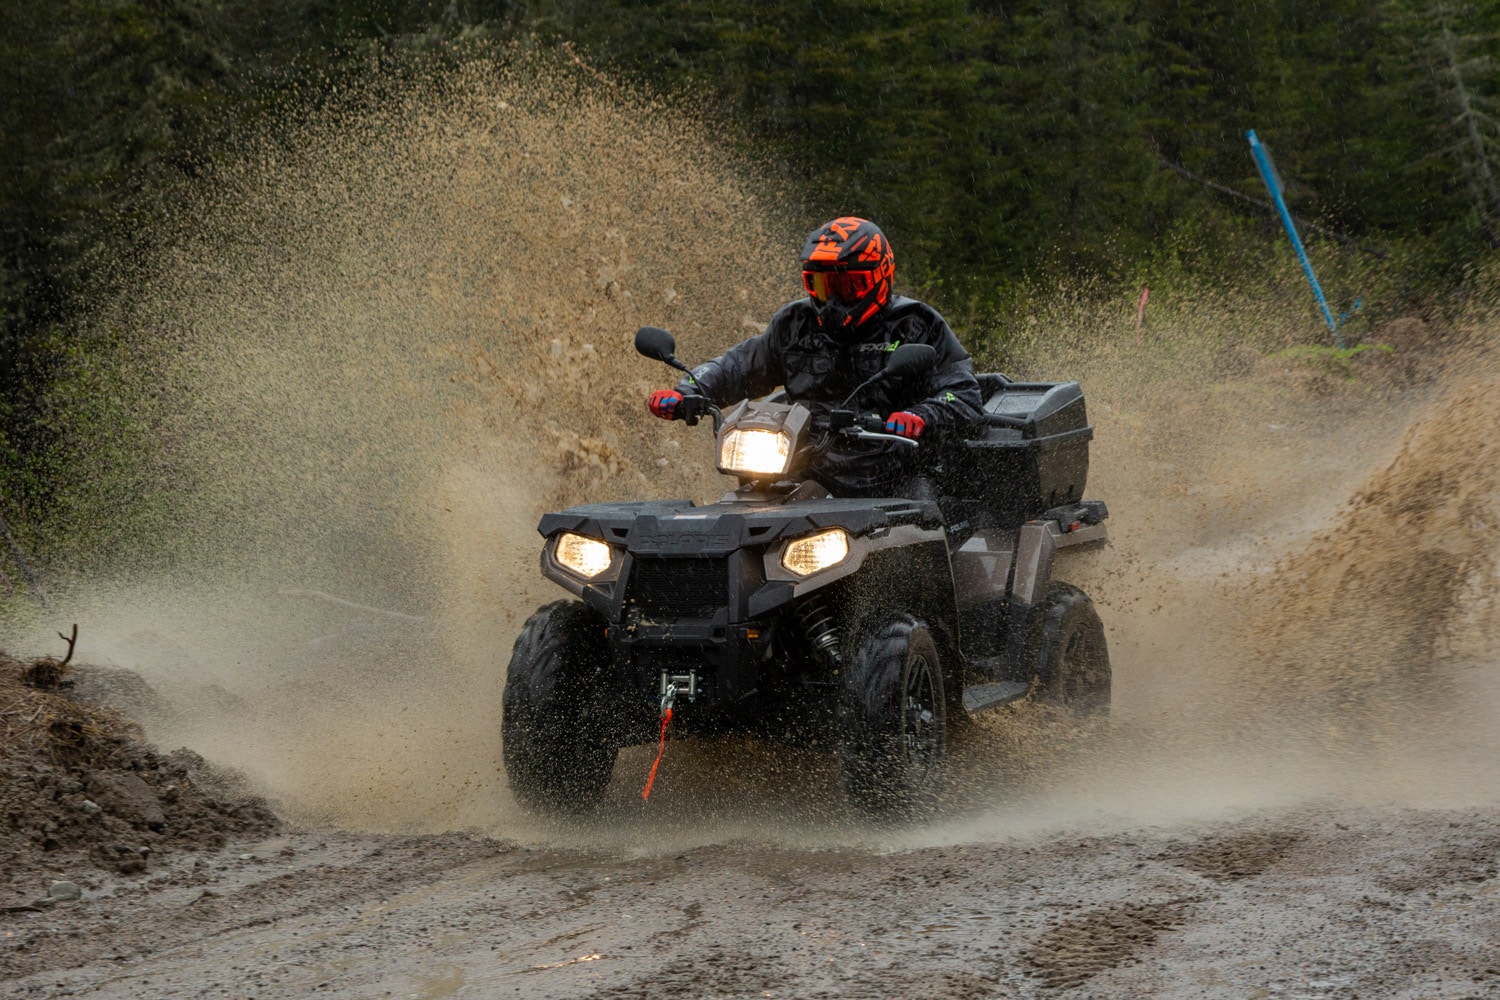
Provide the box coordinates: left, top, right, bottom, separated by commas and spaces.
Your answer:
1247, 378, 1500, 721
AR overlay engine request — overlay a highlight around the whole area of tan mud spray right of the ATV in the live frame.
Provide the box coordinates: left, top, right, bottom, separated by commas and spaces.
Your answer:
917, 315, 1500, 843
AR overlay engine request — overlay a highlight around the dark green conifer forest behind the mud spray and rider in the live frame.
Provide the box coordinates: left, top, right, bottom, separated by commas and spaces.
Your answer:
0, 0, 1500, 560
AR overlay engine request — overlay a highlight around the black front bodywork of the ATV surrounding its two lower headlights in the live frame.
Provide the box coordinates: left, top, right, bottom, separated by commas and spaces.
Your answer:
539, 498, 962, 735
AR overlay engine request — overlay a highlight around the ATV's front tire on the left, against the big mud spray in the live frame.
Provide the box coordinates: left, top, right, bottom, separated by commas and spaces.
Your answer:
500, 601, 620, 813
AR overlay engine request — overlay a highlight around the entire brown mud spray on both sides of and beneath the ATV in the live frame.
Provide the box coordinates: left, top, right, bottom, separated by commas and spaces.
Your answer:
8, 44, 1500, 850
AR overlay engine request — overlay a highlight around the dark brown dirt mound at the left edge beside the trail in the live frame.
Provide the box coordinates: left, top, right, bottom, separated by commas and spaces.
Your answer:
0, 655, 278, 906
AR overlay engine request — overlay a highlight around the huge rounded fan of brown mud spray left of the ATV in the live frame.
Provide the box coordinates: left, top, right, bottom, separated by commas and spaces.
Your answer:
8, 51, 800, 829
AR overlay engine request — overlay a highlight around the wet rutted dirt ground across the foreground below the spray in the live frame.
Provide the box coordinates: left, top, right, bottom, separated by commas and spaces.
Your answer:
0, 808, 1500, 1000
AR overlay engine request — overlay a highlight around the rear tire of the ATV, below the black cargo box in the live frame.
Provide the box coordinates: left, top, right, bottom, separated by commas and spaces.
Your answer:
1037, 583, 1112, 717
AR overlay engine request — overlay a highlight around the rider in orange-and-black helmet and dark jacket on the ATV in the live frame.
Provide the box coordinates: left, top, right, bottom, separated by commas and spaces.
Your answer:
647, 216, 983, 496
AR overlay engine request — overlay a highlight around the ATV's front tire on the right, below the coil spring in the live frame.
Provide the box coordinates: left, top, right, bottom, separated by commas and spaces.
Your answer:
839, 615, 948, 820
